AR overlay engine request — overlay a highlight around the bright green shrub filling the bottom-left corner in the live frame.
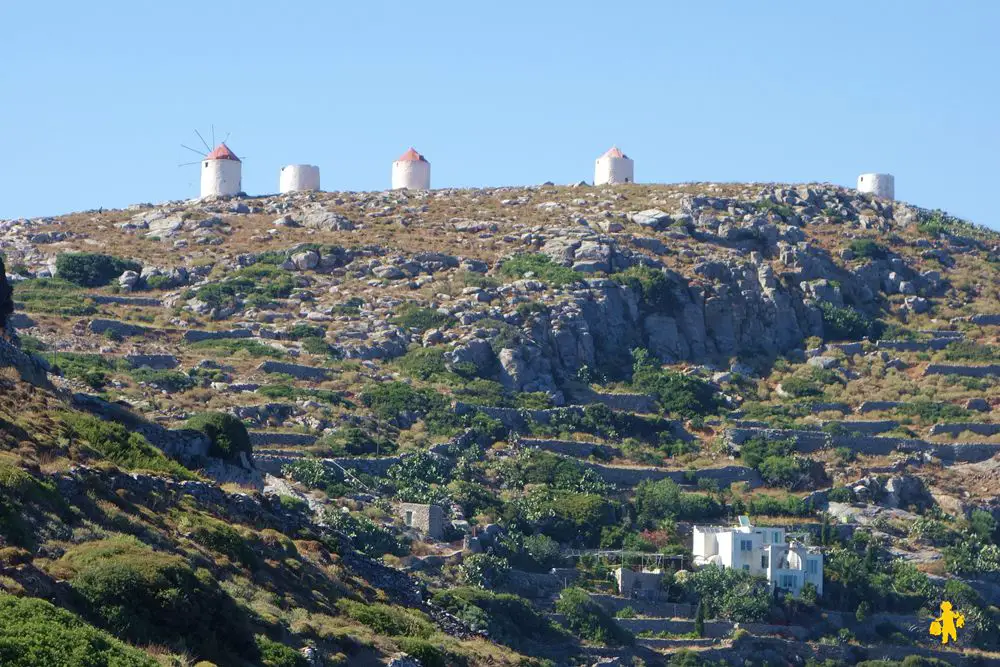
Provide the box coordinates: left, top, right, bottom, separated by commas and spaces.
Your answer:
0, 593, 159, 667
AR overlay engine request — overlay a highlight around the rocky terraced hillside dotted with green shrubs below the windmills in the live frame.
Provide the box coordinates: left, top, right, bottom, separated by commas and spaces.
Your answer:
0, 184, 1000, 667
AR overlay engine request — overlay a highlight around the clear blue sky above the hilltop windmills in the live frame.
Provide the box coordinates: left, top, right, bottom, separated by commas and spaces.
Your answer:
0, 0, 1000, 227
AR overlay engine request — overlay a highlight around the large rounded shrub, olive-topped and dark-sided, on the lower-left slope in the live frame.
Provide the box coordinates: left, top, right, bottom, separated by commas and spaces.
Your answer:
56, 538, 253, 657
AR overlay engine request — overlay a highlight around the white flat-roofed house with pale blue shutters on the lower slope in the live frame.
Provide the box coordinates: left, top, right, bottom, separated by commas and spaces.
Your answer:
692, 516, 823, 596
